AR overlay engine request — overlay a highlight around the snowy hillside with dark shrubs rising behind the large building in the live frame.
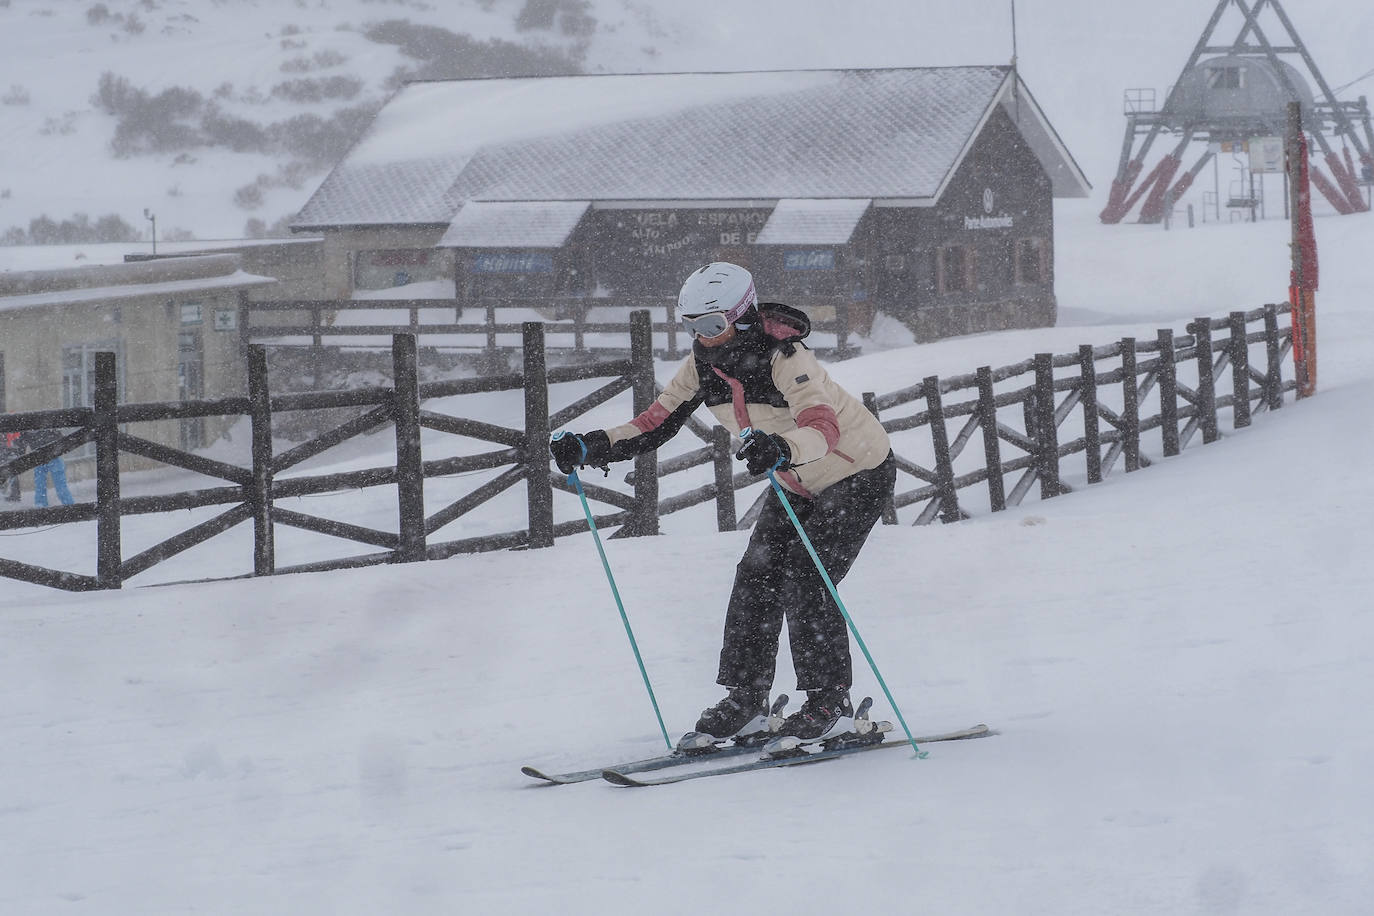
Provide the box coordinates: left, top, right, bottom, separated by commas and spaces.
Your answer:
0, 0, 1374, 243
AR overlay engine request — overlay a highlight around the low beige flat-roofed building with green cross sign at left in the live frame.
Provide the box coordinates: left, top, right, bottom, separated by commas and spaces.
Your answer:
0, 254, 276, 478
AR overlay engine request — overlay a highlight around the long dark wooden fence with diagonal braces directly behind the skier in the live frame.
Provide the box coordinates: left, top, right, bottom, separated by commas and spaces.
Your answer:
0, 305, 1296, 591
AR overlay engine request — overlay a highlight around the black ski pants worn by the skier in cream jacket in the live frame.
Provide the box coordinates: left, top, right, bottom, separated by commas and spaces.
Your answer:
716, 455, 897, 691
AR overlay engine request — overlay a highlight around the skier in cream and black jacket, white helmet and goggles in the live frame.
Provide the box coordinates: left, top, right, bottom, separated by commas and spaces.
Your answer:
550, 261, 896, 742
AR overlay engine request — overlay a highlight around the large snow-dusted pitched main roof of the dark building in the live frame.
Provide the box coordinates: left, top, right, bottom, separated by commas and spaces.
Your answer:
294, 66, 1090, 229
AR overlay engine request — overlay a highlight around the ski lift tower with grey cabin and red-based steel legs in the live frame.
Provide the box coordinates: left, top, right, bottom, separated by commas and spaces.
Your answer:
1101, 0, 1374, 224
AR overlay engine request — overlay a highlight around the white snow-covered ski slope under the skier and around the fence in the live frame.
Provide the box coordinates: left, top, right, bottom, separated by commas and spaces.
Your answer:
0, 193, 1374, 916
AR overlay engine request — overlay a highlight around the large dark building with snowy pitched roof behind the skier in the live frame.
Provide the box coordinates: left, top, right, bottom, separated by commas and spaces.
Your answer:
291, 66, 1090, 339
